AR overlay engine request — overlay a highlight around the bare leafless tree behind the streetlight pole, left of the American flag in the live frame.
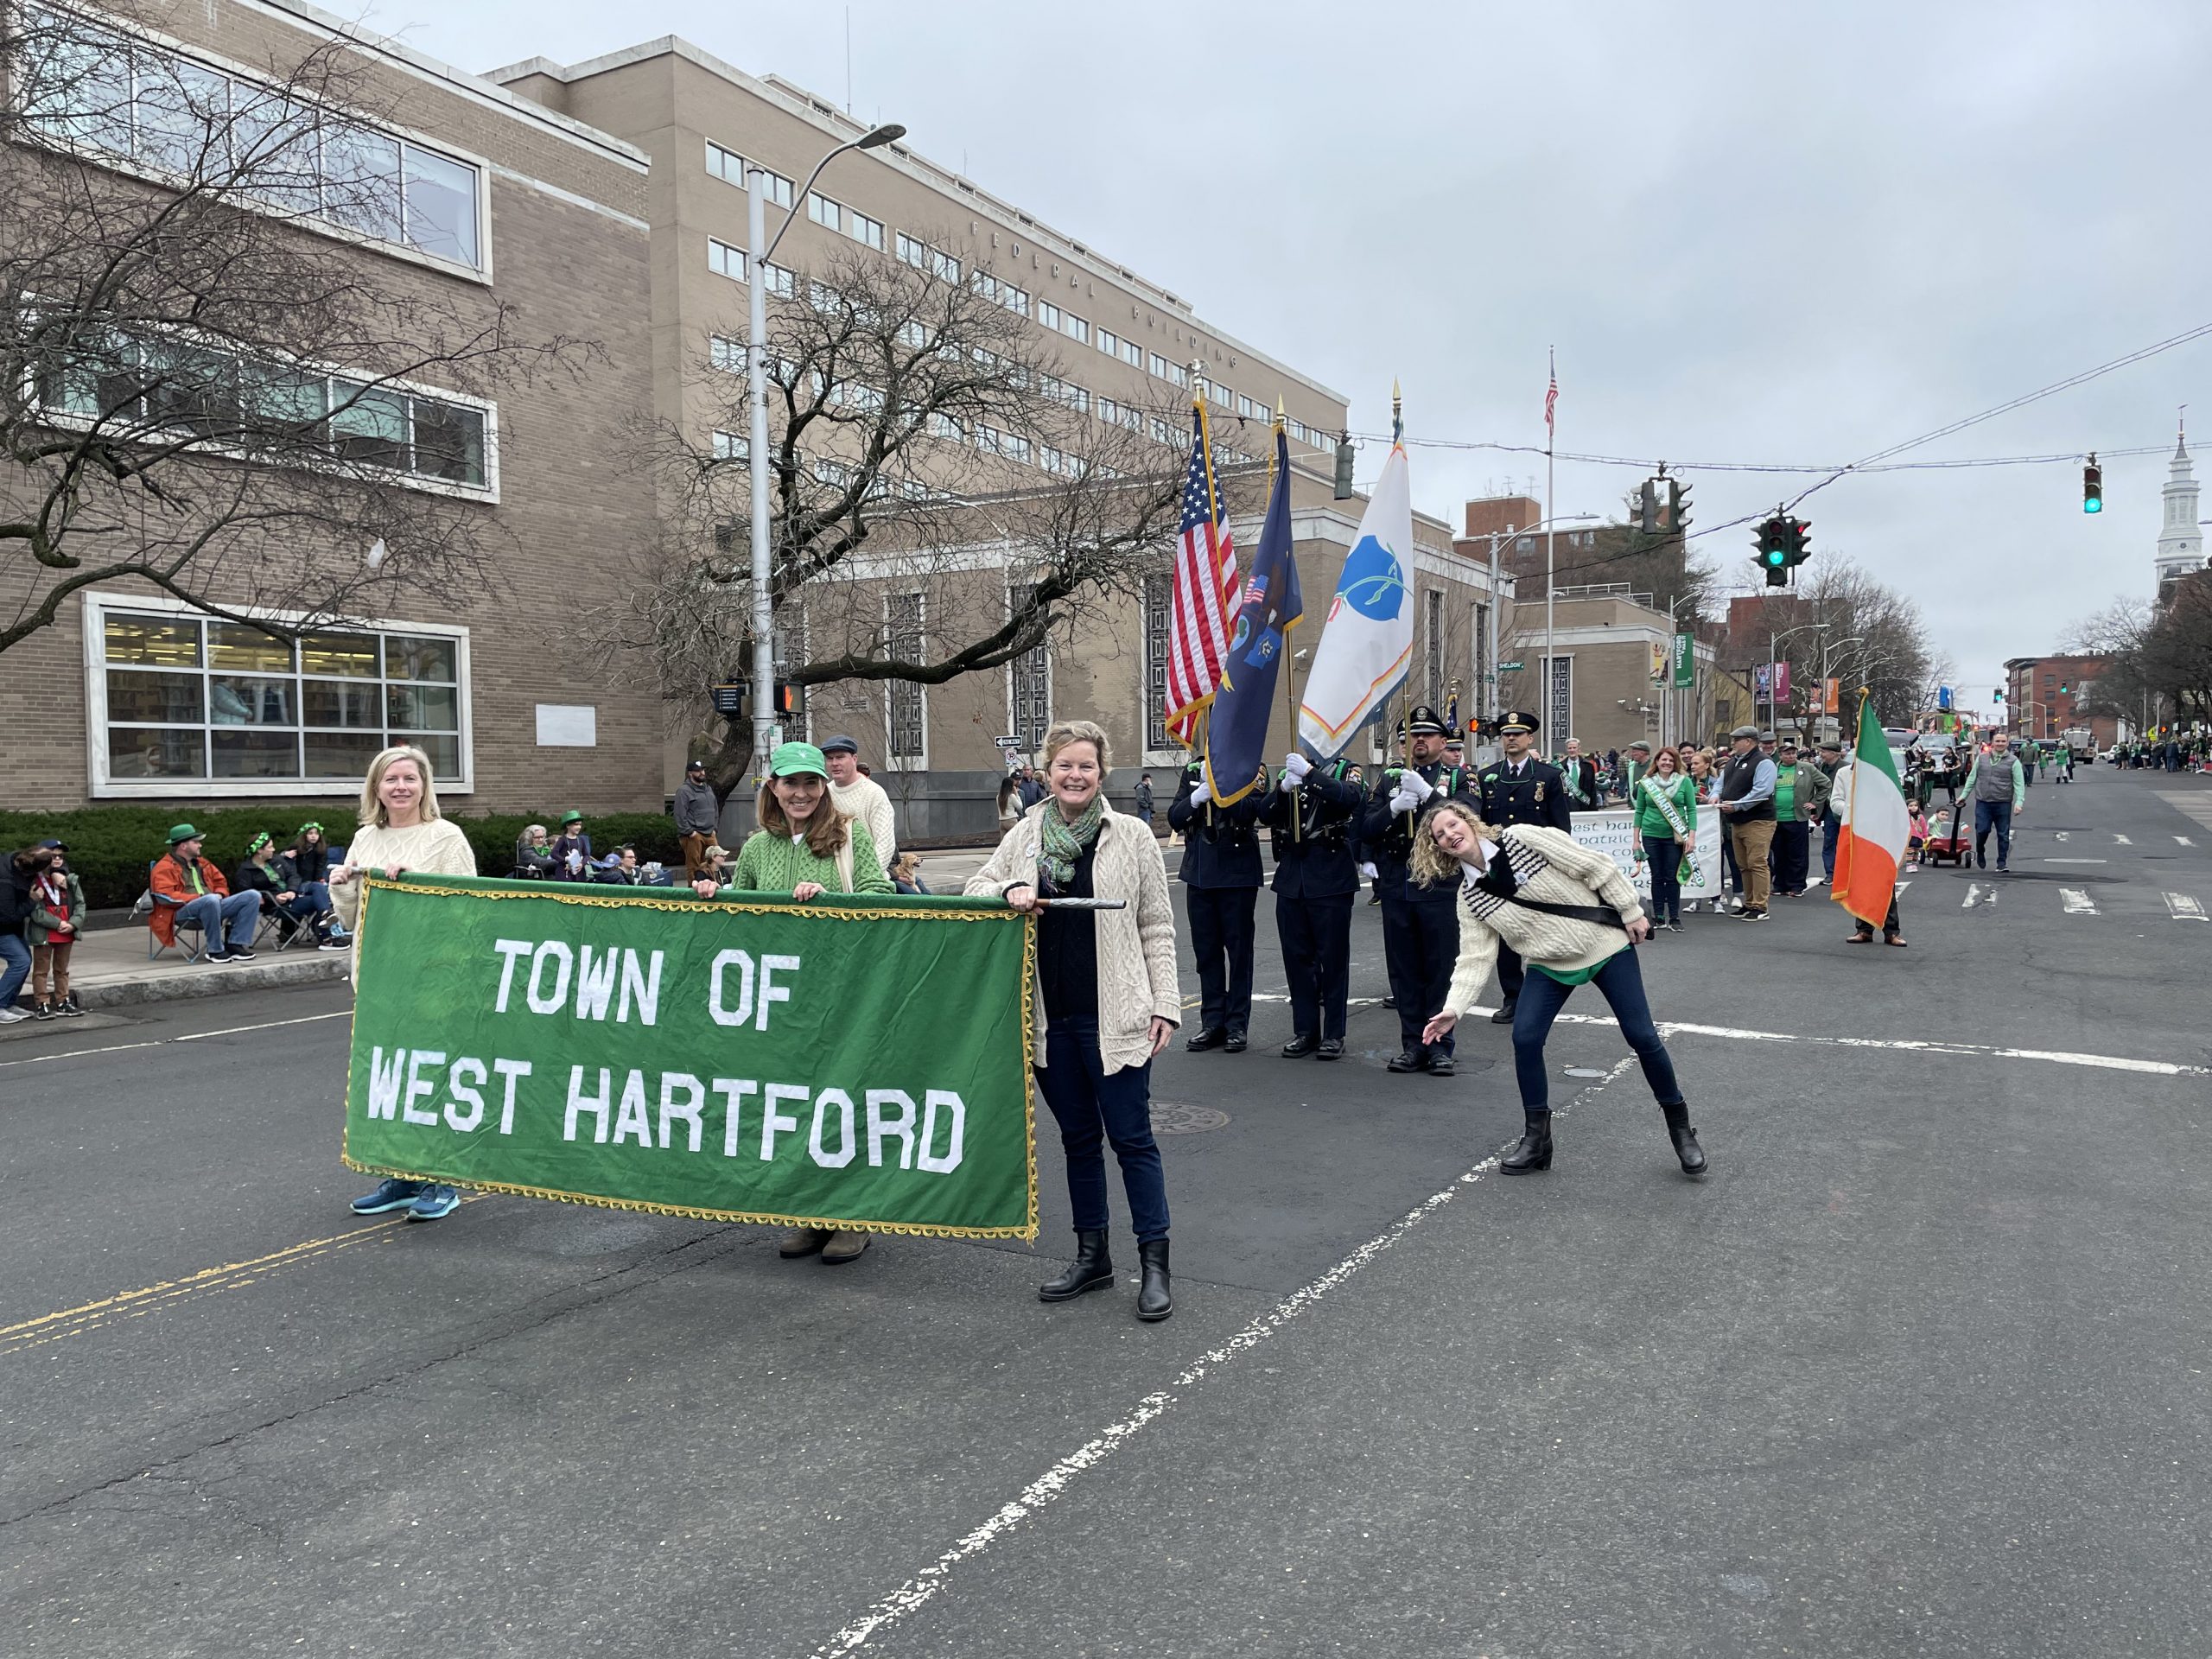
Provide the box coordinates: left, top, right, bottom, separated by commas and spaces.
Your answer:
577, 239, 1194, 791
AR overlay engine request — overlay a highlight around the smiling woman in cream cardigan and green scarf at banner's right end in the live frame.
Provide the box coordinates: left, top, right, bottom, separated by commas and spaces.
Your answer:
967, 721, 1184, 1320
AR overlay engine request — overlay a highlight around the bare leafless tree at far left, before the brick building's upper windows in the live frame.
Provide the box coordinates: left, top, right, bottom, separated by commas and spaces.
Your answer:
0, 0, 593, 651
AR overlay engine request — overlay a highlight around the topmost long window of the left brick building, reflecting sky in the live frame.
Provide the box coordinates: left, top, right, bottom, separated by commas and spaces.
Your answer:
22, 13, 485, 270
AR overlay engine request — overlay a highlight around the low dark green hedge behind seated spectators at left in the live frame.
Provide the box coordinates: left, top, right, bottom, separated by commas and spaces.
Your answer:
0, 797, 683, 909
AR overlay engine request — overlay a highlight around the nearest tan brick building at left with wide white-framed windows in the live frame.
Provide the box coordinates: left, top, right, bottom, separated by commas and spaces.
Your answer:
0, 0, 661, 817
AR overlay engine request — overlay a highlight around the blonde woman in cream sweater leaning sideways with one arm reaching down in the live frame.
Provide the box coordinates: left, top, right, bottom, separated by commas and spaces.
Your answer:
1414, 801, 1706, 1174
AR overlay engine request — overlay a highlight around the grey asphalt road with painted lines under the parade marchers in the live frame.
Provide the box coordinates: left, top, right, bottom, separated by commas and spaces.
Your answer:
0, 767, 2212, 1659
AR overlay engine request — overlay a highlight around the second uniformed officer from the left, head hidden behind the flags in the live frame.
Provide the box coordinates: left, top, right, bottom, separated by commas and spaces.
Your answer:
1261, 752, 1367, 1059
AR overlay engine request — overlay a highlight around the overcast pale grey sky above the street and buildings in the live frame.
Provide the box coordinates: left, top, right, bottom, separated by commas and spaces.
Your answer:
389, 0, 2212, 706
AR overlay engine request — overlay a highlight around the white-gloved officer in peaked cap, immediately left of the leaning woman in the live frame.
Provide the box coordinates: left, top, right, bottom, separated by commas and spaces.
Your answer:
1360, 703, 1469, 1077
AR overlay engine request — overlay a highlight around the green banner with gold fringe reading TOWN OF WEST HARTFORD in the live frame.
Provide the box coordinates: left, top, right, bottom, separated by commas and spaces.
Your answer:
343, 876, 1038, 1239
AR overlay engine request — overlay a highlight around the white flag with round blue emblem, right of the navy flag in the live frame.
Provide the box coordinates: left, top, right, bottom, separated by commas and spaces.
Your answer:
1299, 445, 1414, 761
